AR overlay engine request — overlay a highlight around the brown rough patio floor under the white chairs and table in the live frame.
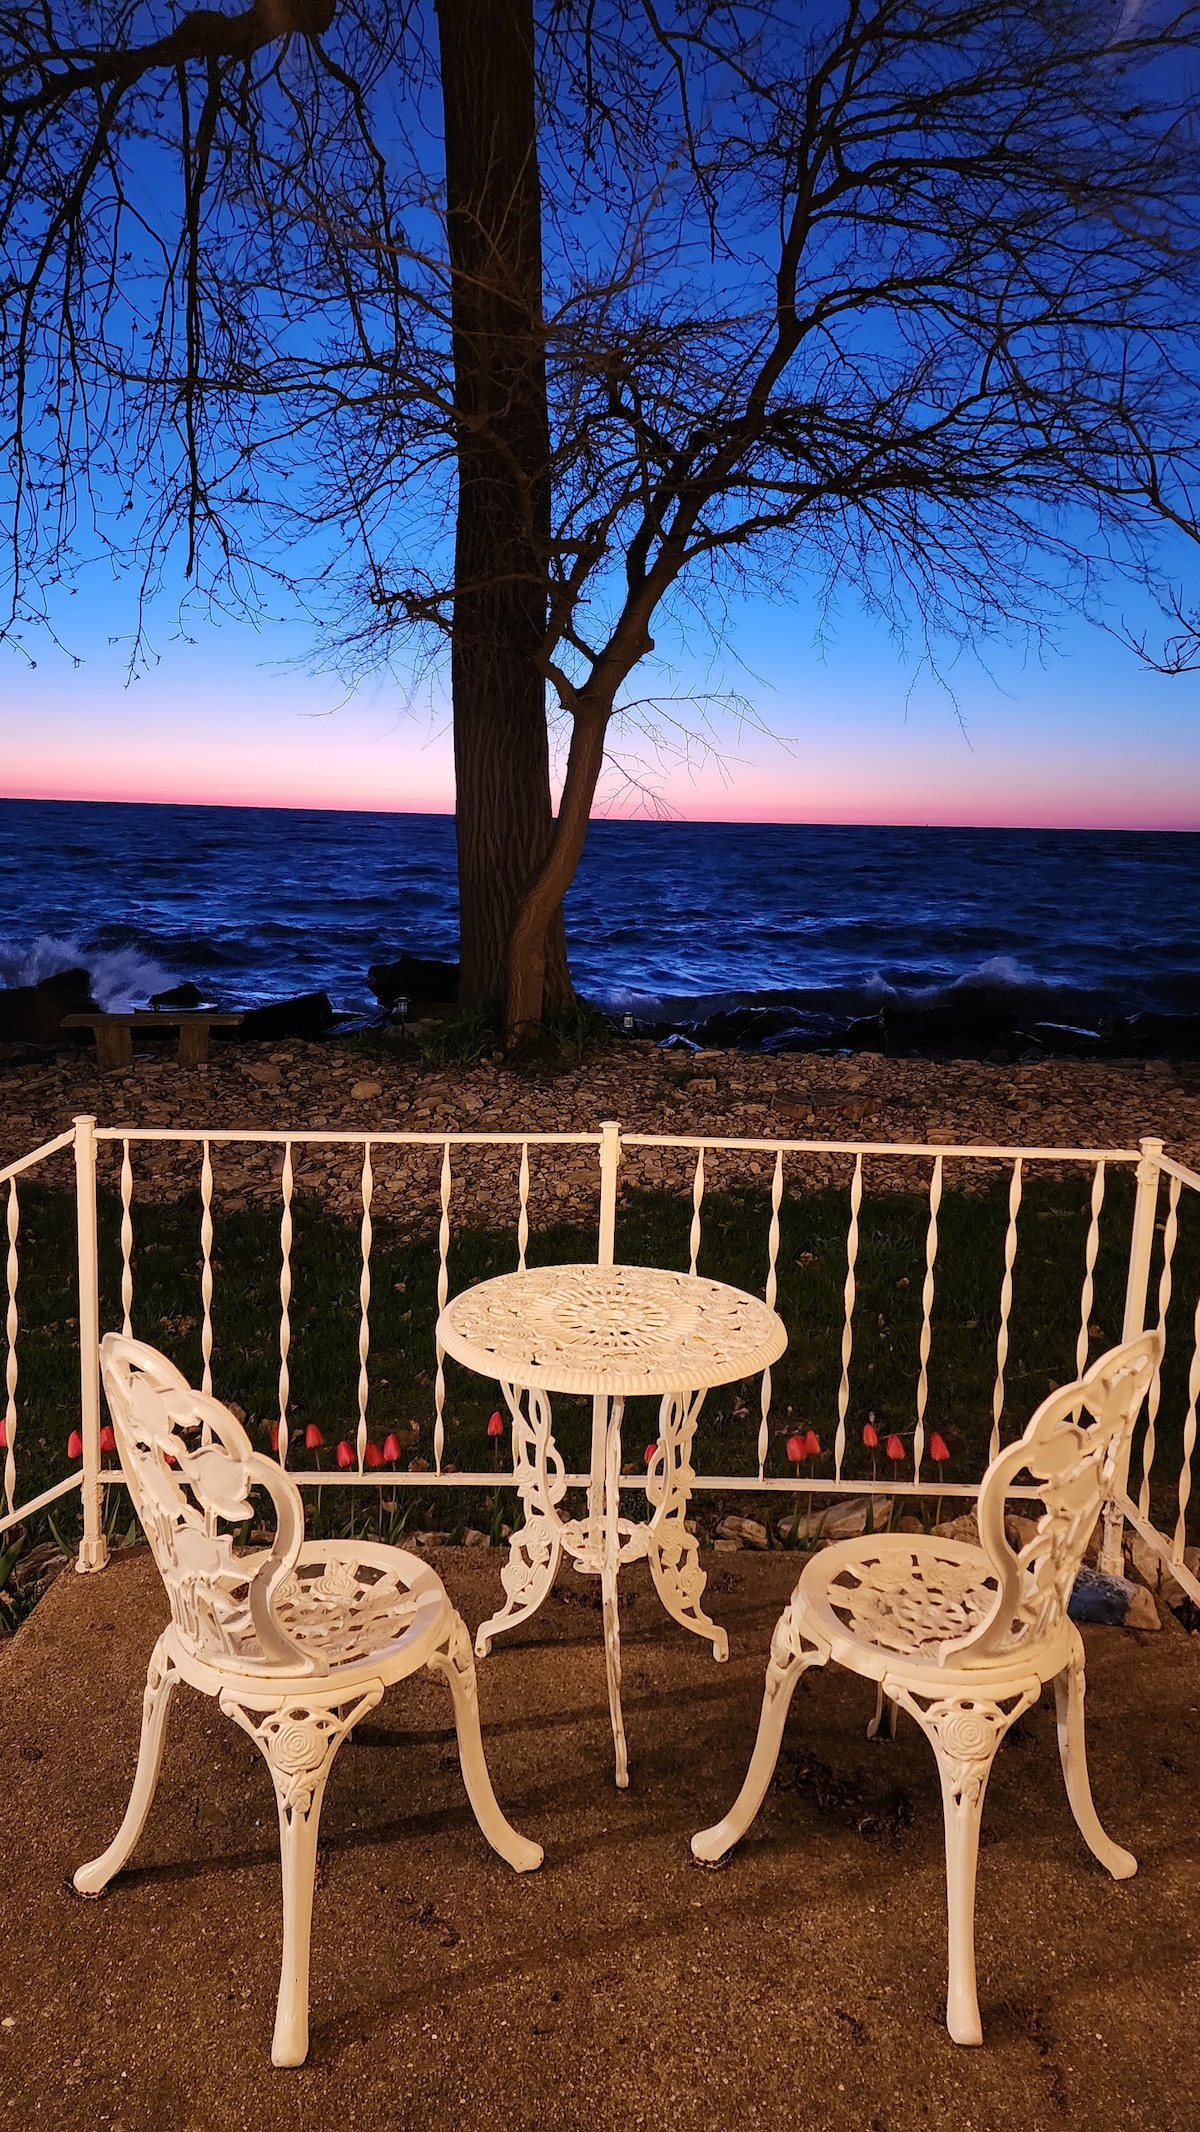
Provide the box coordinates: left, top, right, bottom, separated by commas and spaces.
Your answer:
0, 1552, 1200, 2132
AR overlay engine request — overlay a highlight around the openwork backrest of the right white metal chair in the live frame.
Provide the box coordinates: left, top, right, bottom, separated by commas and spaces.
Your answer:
938, 1333, 1164, 1665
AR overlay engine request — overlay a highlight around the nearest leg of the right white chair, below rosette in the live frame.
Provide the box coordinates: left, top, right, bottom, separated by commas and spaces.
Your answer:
899, 1693, 1036, 2042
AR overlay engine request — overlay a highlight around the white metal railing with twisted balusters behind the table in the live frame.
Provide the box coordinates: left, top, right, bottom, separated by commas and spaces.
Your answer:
0, 1117, 1200, 1601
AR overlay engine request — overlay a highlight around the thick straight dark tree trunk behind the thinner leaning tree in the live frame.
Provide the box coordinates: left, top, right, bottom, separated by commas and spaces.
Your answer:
437, 0, 571, 1019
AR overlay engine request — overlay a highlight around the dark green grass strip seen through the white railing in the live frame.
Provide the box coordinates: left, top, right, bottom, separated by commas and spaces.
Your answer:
4, 1175, 1200, 1535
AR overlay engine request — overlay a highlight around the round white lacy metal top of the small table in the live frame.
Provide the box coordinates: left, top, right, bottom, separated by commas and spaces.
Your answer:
437, 1266, 787, 1399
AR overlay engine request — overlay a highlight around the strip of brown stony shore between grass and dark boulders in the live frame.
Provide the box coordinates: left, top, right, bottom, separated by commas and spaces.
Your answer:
0, 1040, 1200, 1228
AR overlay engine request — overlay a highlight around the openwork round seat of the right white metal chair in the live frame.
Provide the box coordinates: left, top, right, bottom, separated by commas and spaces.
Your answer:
793, 1533, 1057, 1680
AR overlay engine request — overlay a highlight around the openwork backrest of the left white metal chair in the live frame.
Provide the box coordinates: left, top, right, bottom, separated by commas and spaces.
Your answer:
100, 1333, 328, 1674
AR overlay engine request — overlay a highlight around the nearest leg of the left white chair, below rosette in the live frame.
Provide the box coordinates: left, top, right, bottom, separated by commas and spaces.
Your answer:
222, 1684, 384, 2066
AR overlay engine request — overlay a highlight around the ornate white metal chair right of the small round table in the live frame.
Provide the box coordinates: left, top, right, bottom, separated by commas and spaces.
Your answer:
693, 1333, 1164, 2042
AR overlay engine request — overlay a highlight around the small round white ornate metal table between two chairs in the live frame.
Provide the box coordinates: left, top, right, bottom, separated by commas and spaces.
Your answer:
437, 1266, 787, 1787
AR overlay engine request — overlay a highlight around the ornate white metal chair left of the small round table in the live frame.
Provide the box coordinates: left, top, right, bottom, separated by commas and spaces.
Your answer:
75, 1333, 541, 2066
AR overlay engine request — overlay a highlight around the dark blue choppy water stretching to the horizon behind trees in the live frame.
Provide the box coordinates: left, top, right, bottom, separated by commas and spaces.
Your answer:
0, 800, 1200, 1021
